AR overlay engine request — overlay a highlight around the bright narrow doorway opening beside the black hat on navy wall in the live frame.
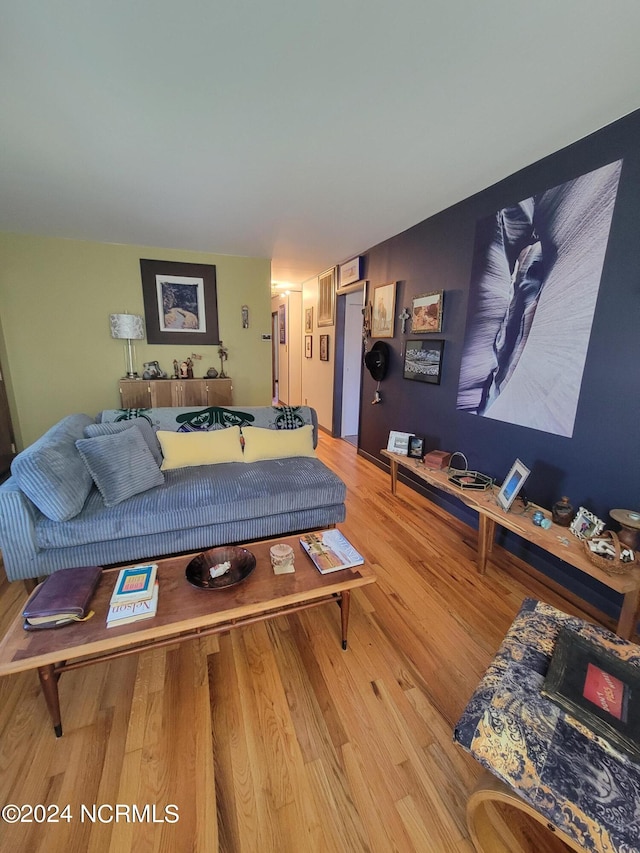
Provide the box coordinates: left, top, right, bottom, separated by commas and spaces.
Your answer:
340, 290, 363, 447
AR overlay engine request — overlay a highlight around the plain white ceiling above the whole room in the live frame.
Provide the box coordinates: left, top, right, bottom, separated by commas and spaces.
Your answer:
0, 0, 640, 283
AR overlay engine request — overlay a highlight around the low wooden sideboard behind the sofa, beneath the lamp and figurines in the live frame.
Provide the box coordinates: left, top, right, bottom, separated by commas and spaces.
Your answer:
120, 379, 233, 409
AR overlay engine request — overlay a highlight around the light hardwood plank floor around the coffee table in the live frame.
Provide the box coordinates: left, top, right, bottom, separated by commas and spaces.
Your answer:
0, 435, 604, 853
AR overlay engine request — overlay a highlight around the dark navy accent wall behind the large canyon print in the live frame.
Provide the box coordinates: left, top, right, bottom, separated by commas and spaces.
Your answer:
359, 110, 640, 611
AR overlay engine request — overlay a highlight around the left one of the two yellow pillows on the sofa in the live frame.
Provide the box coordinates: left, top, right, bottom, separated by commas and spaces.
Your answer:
156, 426, 242, 471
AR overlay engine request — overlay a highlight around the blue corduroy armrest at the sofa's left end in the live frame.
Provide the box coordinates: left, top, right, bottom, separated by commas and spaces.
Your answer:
0, 477, 39, 581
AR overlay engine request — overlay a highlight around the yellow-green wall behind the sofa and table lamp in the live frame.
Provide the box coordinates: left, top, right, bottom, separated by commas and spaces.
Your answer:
0, 234, 271, 449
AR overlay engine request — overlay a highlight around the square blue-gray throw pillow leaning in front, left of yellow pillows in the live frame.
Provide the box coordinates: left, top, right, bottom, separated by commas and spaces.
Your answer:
76, 427, 164, 507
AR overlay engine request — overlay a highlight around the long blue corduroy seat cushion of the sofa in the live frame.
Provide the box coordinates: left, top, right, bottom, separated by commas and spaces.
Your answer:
36, 457, 346, 550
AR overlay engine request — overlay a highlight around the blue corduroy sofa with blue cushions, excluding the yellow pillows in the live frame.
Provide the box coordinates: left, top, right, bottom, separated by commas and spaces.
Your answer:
0, 406, 346, 581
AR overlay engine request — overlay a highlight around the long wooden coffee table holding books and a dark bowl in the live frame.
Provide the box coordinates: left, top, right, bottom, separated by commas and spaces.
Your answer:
0, 536, 375, 737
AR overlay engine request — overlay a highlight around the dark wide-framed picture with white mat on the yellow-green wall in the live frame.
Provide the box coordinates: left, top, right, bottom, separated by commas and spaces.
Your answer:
140, 258, 220, 346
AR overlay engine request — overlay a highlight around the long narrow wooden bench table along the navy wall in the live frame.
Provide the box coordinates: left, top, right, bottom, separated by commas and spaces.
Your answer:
380, 450, 640, 640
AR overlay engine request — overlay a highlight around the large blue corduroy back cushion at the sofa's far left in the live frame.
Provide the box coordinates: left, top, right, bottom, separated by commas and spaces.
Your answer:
11, 415, 94, 521
